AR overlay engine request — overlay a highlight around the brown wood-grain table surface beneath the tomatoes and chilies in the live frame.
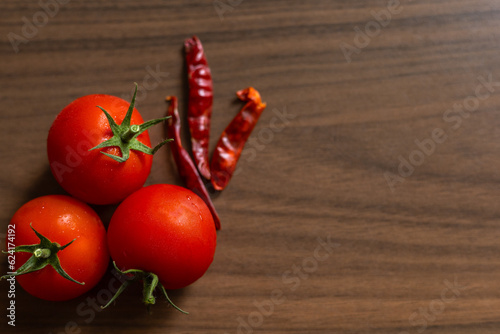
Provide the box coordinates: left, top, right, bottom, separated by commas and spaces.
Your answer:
0, 0, 500, 334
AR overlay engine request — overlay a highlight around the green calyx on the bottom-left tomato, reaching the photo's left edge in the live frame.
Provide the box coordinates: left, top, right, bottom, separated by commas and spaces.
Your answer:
0, 223, 85, 285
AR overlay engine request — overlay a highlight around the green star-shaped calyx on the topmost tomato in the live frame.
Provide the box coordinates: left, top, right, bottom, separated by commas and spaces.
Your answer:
89, 83, 172, 162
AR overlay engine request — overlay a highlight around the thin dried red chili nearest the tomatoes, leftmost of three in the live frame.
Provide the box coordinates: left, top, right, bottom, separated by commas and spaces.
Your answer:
167, 96, 220, 230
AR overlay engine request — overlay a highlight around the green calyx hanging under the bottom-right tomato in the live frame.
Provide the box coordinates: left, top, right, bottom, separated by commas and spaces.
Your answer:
101, 261, 189, 314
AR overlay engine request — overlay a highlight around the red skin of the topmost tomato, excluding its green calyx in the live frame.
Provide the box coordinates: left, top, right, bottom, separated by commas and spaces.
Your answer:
47, 94, 153, 204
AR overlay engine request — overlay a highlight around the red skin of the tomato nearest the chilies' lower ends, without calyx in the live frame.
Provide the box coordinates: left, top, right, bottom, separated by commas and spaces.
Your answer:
108, 184, 217, 289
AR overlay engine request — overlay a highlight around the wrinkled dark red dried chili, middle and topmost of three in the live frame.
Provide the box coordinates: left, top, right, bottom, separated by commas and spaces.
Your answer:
184, 36, 213, 179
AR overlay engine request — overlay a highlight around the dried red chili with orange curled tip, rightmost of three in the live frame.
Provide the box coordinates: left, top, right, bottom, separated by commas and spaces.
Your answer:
210, 87, 266, 190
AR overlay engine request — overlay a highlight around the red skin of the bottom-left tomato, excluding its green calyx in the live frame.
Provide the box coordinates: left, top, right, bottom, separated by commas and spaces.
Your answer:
10, 195, 109, 301
